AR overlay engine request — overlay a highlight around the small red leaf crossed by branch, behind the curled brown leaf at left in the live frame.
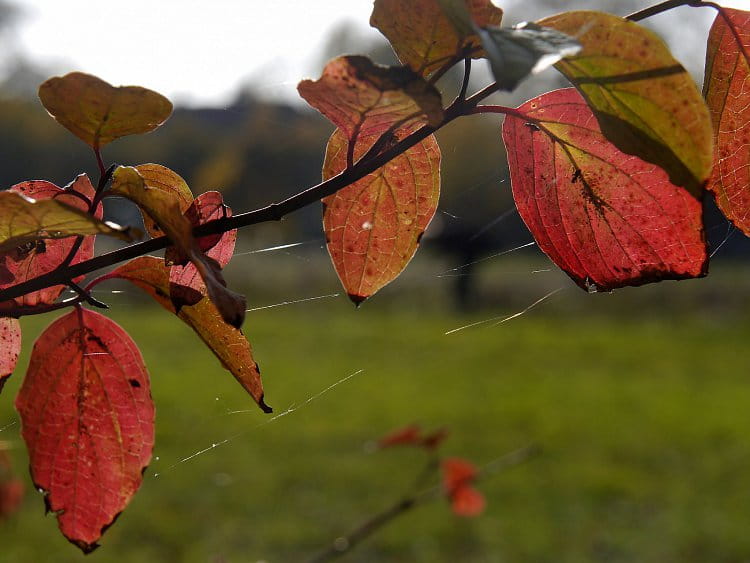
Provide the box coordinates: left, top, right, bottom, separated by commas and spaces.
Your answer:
166, 191, 237, 311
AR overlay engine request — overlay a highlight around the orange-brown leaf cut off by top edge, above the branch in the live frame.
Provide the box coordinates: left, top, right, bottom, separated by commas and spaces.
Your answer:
370, 0, 503, 76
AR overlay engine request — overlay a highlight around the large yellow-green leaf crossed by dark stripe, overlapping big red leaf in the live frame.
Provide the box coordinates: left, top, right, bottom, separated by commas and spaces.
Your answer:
538, 12, 713, 197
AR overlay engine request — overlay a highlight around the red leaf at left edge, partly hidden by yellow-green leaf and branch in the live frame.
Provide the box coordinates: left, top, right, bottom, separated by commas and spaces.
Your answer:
0, 174, 102, 307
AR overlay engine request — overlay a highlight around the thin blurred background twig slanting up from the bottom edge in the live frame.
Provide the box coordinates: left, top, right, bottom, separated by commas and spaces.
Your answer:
308, 444, 541, 563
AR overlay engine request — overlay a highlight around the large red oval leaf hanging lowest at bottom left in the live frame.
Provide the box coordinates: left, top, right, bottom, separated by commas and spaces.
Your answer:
16, 309, 154, 553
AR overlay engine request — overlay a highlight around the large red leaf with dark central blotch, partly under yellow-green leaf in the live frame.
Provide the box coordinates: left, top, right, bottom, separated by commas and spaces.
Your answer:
503, 88, 708, 291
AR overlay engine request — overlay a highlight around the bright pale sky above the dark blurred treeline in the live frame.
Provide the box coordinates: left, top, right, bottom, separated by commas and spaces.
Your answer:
4, 0, 750, 105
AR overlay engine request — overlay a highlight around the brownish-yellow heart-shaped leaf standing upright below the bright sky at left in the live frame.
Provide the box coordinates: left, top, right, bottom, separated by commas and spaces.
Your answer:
39, 73, 172, 148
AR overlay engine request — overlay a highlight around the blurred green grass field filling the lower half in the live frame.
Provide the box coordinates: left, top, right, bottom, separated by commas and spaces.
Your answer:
0, 258, 750, 563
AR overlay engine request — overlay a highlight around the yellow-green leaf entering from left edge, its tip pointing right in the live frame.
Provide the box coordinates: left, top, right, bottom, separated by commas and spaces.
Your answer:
0, 191, 133, 251
